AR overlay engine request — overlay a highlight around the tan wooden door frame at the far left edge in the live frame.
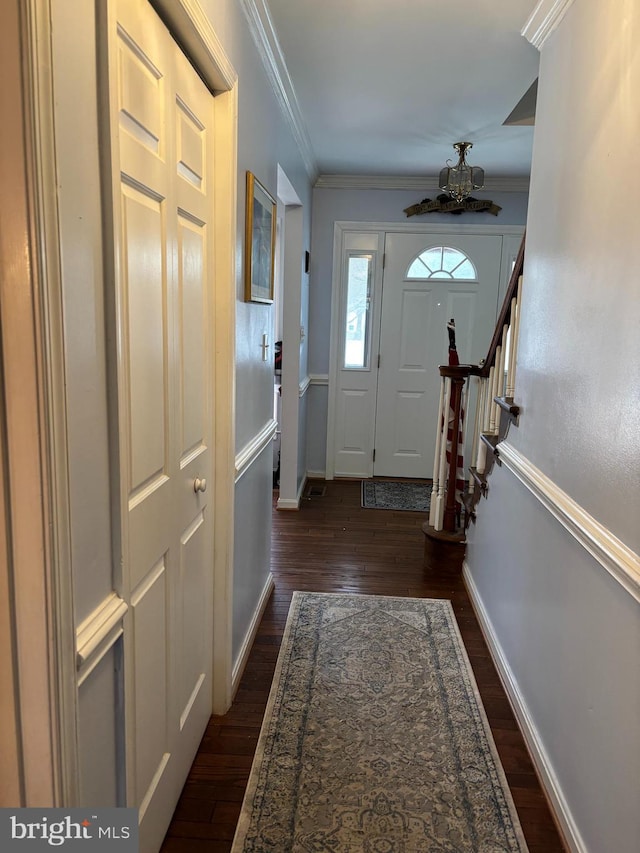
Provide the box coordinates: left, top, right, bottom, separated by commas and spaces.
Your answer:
0, 0, 77, 806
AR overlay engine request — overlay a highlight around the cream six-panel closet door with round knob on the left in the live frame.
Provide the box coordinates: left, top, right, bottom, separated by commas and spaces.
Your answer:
108, 0, 214, 853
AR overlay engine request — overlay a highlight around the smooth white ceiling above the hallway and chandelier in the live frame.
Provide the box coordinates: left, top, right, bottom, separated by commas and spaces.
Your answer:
266, 0, 538, 180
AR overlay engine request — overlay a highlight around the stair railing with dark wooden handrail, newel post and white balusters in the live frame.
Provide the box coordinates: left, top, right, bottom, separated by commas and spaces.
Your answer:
423, 237, 525, 540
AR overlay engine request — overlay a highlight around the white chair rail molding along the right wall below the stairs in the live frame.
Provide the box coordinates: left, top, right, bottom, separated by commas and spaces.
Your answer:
498, 441, 640, 602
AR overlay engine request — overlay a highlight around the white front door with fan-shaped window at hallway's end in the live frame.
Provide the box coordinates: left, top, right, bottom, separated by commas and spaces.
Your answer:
373, 234, 502, 477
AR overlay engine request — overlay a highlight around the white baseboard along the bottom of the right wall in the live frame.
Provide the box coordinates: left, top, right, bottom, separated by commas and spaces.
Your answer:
462, 560, 587, 853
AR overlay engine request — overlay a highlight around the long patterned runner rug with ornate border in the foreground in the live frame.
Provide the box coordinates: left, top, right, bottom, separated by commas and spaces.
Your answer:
232, 592, 527, 853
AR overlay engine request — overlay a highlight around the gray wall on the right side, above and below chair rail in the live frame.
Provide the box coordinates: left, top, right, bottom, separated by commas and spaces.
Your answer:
468, 0, 640, 853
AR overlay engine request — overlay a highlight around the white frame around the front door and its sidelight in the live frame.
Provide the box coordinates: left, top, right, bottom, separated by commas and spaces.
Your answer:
325, 220, 525, 480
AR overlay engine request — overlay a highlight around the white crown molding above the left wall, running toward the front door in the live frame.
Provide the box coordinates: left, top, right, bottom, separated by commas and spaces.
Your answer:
241, 0, 318, 183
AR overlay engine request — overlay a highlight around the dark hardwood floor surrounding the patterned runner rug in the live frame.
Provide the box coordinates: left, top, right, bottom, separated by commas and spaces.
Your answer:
162, 480, 566, 853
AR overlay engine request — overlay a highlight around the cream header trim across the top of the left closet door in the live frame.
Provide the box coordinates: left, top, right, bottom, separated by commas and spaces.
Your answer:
151, 0, 238, 93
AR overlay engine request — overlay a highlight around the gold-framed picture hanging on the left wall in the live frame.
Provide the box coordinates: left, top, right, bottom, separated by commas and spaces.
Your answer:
244, 172, 276, 302
